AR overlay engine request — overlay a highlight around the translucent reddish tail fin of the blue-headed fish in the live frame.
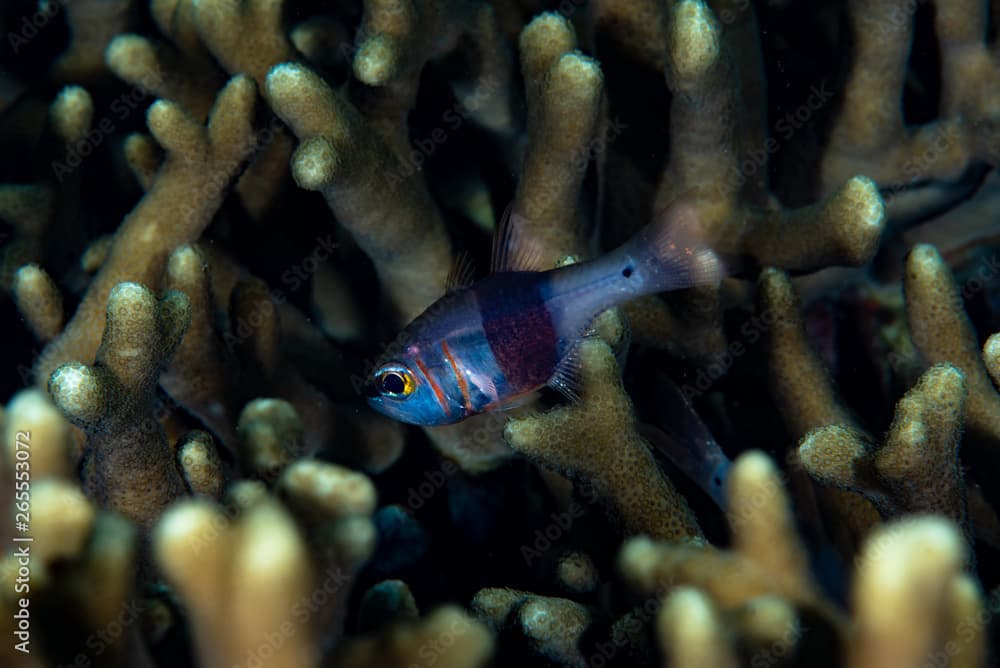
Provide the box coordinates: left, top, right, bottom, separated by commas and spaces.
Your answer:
622, 198, 727, 292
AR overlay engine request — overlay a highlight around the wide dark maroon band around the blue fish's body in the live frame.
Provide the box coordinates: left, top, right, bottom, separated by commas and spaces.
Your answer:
475, 272, 559, 391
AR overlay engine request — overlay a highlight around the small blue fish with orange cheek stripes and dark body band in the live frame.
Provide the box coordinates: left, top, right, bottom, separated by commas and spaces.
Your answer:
365, 201, 723, 426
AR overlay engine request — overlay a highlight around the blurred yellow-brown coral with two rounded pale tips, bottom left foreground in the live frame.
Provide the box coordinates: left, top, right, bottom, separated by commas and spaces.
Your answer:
154, 498, 319, 667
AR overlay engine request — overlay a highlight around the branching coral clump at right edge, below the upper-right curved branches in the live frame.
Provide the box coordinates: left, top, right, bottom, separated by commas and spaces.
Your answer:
760, 247, 996, 548
